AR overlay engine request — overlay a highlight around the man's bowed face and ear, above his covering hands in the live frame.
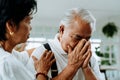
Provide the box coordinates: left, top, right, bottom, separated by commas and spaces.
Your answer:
59, 21, 92, 52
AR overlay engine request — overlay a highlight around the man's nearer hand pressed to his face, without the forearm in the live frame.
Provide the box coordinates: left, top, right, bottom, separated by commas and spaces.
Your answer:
68, 39, 91, 69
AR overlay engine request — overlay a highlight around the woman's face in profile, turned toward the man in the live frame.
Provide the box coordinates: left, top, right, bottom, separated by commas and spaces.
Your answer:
13, 16, 32, 44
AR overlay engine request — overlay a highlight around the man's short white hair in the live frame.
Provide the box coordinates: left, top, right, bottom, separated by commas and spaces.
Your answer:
60, 8, 96, 32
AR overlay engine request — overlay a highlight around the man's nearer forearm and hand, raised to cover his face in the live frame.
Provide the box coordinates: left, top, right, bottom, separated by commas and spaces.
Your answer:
52, 39, 91, 80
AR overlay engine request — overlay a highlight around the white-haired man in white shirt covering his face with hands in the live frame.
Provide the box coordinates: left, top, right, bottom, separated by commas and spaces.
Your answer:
27, 8, 101, 80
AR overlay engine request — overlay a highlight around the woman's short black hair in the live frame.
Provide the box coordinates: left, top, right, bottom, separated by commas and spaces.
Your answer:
0, 0, 37, 41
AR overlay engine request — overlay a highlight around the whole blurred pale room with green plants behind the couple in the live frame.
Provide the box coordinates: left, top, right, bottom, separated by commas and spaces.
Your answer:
15, 0, 120, 80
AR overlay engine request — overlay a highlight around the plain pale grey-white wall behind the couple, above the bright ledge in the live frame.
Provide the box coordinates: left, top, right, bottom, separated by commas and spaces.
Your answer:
31, 0, 120, 39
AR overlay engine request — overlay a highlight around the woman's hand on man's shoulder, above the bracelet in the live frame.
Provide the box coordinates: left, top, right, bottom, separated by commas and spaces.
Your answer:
32, 50, 55, 75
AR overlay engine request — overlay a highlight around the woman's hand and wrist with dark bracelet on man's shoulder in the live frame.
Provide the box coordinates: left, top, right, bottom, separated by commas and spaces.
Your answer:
32, 50, 55, 80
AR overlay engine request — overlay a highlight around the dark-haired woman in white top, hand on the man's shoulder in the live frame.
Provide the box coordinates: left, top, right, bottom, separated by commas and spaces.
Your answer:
0, 0, 55, 80
